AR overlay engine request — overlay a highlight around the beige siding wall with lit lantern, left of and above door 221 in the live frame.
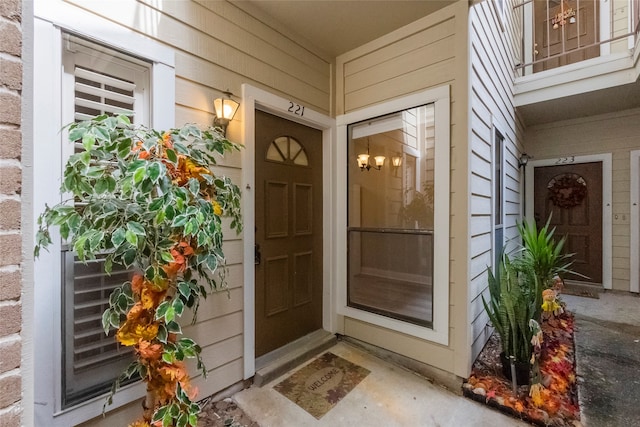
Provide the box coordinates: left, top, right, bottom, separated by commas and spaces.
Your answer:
60, 0, 332, 425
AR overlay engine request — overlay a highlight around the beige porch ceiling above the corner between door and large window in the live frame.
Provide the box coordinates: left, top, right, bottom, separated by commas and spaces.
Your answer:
233, 0, 455, 59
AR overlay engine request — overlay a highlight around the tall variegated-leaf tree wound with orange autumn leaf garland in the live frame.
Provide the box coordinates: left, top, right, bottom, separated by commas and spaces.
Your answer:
35, 115, 242, 427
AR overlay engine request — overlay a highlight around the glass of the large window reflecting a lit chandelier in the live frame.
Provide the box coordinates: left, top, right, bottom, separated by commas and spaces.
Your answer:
347, 103, 437, 328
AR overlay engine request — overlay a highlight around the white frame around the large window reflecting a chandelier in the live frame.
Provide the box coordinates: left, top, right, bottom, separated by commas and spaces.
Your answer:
335, 85, 451, 345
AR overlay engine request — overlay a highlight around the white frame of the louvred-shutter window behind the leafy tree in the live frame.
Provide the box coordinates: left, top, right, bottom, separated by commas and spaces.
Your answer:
31, 0, 175, 426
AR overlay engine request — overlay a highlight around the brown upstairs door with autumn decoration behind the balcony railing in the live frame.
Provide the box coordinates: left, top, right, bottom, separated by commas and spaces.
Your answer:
533, 0, 600, 72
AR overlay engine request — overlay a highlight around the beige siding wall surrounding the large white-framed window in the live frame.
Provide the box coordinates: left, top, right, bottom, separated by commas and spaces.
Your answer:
336, 2, 468, 376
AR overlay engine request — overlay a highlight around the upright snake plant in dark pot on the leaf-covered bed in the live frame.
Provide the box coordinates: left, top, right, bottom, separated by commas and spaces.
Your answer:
482, 255, 536, 384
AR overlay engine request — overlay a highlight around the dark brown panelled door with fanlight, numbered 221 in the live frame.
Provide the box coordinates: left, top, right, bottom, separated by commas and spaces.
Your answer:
255, 110, 322, 356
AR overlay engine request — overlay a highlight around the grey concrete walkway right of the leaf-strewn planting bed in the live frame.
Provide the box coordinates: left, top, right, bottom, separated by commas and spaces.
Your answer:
562, 291, 640, 427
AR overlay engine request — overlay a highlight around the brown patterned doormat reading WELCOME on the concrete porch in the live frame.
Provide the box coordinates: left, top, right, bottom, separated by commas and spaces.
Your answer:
273, 353, 369, 419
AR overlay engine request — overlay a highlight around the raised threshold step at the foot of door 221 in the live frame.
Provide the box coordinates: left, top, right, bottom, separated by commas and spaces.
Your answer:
253, 329, 338, 387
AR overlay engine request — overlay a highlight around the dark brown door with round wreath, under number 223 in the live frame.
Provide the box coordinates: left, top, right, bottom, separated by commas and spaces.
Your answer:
534, 162, 602, 286
